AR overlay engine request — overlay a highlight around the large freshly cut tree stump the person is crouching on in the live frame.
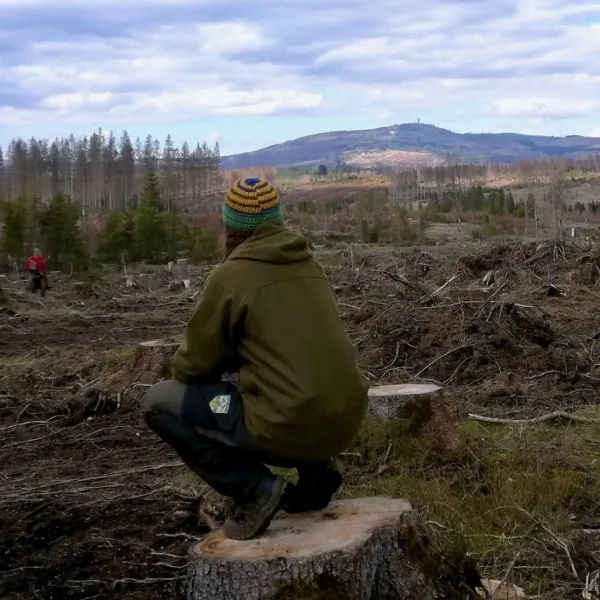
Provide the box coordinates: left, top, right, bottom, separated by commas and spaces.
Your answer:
187, 498, 460, 600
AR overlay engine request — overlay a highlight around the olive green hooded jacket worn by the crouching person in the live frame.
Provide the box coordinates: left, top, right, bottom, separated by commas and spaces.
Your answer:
172, 224, 368, 461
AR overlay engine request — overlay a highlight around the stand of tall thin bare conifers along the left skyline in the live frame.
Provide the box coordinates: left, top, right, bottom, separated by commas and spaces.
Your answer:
0, 129, 222, 214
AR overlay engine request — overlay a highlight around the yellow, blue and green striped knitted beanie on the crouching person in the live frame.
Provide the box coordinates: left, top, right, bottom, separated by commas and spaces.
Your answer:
223, 177, 283, 232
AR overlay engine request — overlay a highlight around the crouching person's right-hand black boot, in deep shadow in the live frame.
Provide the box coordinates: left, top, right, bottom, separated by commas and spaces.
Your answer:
283, 459, 344, 514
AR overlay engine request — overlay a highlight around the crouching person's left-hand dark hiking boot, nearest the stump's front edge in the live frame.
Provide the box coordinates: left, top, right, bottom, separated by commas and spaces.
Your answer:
223, 477, 287, 540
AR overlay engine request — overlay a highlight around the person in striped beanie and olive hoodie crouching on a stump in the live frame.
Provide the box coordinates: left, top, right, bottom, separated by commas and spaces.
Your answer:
143, 178, 368, 540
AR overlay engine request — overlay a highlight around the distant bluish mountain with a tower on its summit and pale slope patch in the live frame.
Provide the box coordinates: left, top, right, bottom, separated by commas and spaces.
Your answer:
221, 123, 600, 169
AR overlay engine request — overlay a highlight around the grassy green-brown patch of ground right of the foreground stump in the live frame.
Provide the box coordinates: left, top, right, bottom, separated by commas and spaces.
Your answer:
343, 409, 600, 597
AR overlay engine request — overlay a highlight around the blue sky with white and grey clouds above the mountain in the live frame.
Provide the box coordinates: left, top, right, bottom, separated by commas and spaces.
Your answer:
0, 0, 600, 154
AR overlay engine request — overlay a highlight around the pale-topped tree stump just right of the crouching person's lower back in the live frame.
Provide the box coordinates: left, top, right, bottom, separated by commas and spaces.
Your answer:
367, 383, 462, 452
